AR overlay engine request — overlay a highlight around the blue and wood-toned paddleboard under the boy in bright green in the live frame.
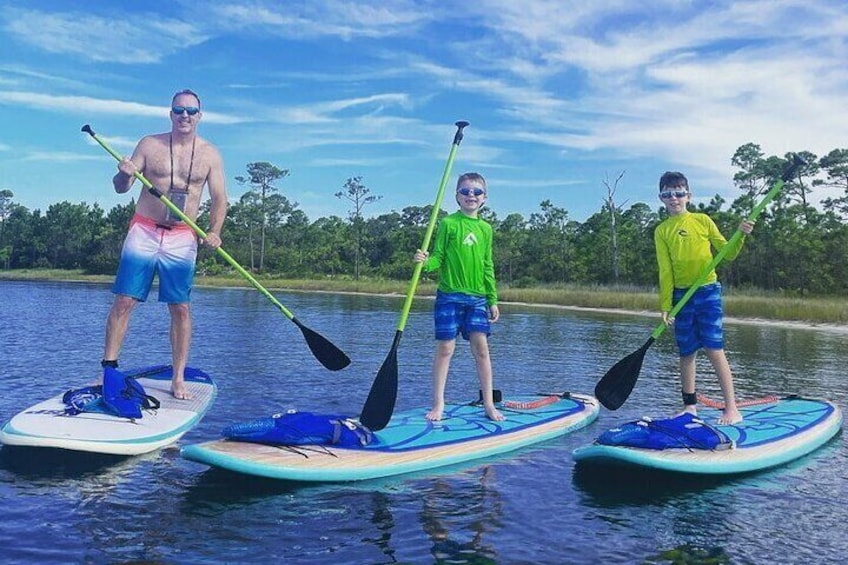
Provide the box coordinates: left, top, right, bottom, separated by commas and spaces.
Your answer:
181, 394, 599, 481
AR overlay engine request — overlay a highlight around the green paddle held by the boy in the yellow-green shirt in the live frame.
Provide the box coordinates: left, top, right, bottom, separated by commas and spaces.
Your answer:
595, 154, 804, 410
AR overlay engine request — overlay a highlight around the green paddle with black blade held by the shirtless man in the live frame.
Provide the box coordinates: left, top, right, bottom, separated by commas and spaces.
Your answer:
82, 124, 350, 371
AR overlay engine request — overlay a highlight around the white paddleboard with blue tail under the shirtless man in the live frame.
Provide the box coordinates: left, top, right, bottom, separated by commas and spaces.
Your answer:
0, 365, 217, 455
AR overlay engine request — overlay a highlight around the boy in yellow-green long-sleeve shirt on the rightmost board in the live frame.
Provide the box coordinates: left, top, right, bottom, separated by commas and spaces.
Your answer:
654, 172, 754, 424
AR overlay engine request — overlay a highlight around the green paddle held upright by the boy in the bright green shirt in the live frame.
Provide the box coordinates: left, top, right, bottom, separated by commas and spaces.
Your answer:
359, 122, 468, 432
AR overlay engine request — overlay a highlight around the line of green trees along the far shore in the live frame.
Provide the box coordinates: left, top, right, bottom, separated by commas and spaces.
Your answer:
0, 143, 848, 295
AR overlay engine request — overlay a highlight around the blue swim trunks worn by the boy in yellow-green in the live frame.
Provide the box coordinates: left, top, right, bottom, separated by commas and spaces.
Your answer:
672, 282, 724, 357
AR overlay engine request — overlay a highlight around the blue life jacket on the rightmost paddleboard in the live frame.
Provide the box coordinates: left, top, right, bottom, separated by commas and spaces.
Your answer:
596, 412, 733, 450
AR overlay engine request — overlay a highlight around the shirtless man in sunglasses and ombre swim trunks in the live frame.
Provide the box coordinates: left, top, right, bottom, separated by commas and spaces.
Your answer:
101, 90, 227, 399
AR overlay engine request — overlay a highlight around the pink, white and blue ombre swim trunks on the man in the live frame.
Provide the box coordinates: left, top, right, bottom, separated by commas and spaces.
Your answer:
112, 214, 197, 304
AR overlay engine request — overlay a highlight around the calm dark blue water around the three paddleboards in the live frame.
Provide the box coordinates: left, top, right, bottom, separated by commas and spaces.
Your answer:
0, 281, 848, 564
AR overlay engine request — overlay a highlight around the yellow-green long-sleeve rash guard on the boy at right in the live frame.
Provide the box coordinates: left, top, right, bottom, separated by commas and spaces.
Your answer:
654, 212, 744, 312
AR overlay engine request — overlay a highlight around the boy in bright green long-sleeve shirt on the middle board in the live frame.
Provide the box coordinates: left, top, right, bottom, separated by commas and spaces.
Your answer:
414, 173, 504, 421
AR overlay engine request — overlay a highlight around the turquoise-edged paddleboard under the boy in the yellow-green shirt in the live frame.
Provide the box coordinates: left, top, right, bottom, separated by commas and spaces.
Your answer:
573, 396, 842, 475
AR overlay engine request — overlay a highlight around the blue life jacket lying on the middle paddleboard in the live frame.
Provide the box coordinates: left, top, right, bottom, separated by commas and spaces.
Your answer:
221, 410, 374, 447
